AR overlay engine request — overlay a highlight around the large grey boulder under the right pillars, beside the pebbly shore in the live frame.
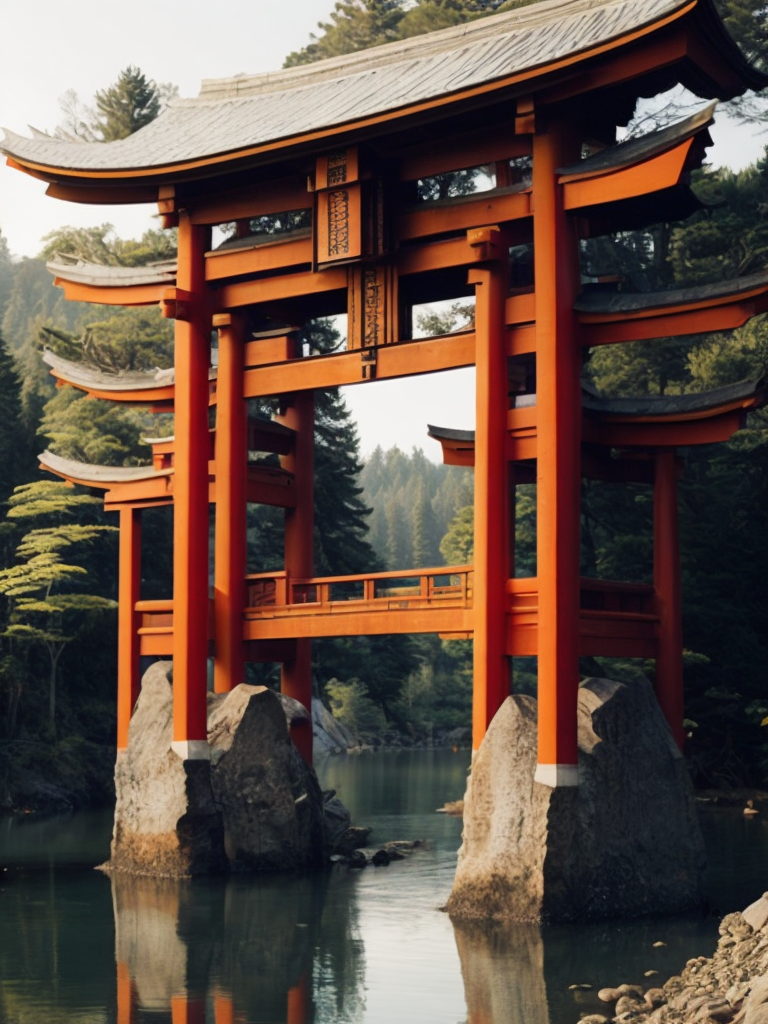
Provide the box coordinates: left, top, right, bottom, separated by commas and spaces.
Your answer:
447, 679, 703, 922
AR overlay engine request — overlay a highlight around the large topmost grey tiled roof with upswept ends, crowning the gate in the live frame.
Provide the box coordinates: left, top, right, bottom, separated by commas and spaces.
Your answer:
2, 0, 762, 174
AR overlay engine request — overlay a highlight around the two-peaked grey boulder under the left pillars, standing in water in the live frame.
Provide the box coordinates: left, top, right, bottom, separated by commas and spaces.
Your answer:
104, 663, 328, 878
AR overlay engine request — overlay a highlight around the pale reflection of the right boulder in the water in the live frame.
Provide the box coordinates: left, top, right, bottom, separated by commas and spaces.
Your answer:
453, 921, 550, 1024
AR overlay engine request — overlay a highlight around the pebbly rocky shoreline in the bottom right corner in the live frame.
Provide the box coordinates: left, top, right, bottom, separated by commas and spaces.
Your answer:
580, 893, 768, 1024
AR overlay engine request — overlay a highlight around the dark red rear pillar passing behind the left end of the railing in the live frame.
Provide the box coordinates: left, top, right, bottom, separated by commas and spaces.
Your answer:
278, 391, 314, 764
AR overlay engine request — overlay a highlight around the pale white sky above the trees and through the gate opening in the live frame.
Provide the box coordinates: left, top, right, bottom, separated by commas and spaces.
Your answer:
0, 0, 768, 459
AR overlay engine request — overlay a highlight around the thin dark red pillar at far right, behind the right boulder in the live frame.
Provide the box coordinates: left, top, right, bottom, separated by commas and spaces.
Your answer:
653, 449, 685, 750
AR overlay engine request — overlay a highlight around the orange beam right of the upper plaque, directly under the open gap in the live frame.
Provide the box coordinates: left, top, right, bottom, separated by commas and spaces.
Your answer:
395, 189, 532, 242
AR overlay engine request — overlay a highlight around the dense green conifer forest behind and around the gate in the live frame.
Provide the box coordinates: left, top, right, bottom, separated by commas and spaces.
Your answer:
0, 0, 768, 809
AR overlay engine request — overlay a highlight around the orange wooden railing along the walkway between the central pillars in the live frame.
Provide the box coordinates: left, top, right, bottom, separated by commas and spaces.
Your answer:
246, 565, 473, 618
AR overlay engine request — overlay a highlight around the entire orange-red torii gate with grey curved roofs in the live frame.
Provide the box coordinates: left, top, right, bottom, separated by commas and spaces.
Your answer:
3, 0, 768, 785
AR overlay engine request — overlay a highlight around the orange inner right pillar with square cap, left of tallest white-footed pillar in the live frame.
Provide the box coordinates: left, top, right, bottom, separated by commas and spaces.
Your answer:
468, 228, 509, 750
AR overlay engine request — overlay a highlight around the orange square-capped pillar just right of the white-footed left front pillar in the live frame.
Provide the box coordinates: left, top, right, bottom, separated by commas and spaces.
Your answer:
213, 313, 248, 693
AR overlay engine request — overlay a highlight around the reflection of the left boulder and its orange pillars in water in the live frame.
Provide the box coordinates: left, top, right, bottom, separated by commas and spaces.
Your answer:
112, 874, 364, 1024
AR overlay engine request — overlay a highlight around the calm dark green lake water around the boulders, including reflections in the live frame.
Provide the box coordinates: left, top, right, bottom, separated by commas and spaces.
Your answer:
0, 751, 768, 1024
